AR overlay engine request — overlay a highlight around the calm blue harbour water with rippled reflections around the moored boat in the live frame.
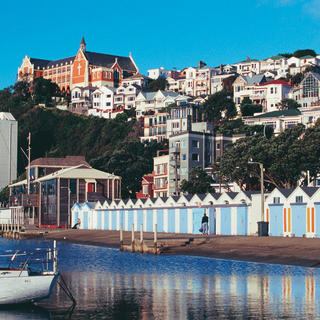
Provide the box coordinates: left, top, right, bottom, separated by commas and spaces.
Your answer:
0, 238, 320, 320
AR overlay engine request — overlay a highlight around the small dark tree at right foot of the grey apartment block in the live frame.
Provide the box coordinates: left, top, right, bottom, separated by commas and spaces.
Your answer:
180, 167, 215, 194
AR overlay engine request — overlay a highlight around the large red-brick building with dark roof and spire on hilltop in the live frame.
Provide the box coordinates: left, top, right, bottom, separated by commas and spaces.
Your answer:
18, 37, 139, 91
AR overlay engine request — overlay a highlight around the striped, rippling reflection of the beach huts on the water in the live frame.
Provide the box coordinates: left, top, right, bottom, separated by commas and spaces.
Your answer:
45, 272, 319, 319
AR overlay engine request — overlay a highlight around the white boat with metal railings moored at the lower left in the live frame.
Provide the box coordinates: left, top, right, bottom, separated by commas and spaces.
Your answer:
0, 241, 59, 305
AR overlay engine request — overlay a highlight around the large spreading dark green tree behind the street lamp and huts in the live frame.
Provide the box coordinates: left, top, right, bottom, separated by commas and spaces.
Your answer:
220, 125, 306, 189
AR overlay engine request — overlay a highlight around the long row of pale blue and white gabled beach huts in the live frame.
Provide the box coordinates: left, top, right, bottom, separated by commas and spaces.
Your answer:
71, 187, 320, 238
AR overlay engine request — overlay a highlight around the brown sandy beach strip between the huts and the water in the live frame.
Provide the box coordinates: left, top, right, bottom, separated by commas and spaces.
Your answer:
38, 229, 320, 268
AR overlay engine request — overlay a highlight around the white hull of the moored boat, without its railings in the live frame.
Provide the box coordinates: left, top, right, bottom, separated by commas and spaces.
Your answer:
0, 272, 58, 305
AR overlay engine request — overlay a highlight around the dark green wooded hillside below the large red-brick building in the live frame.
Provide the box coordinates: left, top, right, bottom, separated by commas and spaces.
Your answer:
0, 88, 163, 197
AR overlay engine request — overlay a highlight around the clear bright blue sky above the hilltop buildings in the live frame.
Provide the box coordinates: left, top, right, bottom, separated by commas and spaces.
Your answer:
0, 0, 320, 89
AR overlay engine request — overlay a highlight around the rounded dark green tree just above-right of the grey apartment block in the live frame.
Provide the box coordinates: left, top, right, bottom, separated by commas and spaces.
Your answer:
200, 90, 237, 122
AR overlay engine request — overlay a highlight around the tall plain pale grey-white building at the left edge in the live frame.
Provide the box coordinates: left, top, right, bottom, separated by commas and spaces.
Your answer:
0, 112, 18, 190
